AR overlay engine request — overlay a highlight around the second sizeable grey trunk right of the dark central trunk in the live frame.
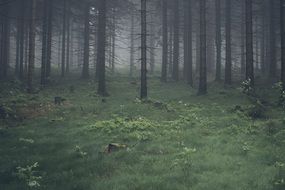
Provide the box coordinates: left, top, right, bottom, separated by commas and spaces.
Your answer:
172, 1, 180, 81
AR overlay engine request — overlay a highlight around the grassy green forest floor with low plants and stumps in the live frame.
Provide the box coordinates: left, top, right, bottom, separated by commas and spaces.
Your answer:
0, 77, 285, 190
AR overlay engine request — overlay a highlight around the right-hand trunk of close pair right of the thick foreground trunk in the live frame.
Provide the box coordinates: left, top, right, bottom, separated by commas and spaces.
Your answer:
225, 0, 232, 85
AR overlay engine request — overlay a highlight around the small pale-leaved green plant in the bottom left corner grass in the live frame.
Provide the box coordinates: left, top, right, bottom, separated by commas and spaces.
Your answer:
16, 162, 42, 188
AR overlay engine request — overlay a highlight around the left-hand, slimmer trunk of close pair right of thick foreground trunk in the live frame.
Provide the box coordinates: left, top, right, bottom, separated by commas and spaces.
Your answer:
216, 0, 222, 81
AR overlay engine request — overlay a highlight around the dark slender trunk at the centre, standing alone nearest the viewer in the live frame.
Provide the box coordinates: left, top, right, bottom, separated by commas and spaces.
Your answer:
140, 0, 147, 99
